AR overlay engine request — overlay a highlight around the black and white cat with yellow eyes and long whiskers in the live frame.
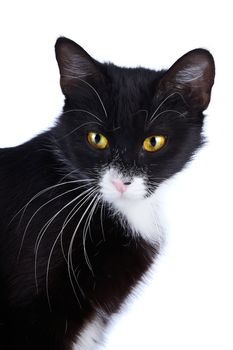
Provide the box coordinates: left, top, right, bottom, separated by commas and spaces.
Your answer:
0, 37, 215, 350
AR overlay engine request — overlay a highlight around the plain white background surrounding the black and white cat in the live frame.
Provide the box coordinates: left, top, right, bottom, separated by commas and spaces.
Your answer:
0, 0, 233, 350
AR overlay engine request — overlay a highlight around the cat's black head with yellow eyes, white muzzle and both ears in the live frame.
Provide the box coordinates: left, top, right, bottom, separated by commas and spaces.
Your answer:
56, 38, 215, 235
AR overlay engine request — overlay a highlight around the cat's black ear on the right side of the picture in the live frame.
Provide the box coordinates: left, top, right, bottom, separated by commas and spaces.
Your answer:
159, 49, 215, 111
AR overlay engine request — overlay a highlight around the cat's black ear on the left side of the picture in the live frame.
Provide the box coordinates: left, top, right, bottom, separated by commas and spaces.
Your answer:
55, 37, 100, 95
